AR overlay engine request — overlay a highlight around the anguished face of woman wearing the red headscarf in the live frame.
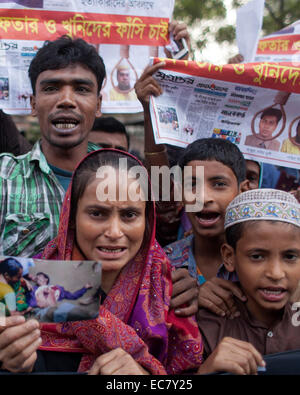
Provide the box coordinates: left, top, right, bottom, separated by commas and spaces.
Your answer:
76, 172, 146, 288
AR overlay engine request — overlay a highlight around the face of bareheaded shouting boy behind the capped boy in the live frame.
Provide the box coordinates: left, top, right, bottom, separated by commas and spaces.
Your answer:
185, 160, 240, 237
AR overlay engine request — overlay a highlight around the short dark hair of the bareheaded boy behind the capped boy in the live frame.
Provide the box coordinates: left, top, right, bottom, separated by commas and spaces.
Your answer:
179, 138, 246, 184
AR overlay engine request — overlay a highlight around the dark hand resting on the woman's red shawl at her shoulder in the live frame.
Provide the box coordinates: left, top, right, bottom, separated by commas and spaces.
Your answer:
170, 269, 199, 317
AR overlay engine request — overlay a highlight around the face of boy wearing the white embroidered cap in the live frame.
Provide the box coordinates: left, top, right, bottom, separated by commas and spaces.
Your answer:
222, 221, 300, 318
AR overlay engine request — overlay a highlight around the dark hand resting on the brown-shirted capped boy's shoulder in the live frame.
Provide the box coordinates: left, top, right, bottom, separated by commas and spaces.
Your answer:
198, 277, 247, 318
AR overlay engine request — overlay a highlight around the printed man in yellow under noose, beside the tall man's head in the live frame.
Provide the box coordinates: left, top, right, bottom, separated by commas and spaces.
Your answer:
109, 64, 137, 101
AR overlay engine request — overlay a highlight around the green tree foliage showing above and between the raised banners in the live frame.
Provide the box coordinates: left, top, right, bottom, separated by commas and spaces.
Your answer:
174, 0, 300, 48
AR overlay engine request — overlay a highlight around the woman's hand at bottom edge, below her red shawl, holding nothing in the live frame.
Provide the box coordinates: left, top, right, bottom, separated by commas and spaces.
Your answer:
89, 348, 149, 375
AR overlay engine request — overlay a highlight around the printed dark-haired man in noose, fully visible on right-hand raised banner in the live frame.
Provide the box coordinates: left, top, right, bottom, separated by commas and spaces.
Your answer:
245, 108, 282, 151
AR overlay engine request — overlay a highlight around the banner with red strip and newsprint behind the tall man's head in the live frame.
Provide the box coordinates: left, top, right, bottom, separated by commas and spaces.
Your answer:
0, 0, 174, 114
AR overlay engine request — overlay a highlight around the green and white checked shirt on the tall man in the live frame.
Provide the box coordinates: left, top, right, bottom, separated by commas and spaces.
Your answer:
0, 142, 99, 257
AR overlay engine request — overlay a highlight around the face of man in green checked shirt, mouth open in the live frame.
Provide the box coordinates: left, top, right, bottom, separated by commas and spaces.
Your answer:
31, 64, 101, 149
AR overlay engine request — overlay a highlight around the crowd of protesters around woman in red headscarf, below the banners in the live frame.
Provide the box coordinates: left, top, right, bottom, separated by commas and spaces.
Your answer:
0, 19, 300, 375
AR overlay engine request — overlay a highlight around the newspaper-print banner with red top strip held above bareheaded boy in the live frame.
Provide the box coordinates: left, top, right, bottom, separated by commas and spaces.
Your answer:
150, 58, 300, 169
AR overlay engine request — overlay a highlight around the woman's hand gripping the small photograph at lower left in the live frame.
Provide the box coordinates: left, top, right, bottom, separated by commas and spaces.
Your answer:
0, 316, 42, 373
